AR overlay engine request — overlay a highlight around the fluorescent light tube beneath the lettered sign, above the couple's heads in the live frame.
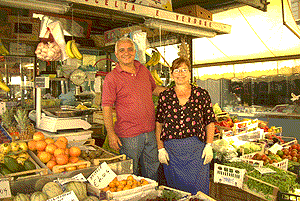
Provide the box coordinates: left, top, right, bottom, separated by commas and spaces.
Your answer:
144, 19, 217, 38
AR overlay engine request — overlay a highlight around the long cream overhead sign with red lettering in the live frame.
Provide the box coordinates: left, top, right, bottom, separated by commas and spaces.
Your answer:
70, 0, 231, 34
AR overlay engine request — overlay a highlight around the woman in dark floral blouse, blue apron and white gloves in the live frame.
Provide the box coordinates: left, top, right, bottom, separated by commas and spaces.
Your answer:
156, 58, 215, 195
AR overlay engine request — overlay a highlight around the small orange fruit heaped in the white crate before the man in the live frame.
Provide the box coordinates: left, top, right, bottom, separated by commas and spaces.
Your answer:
101, 175, 149, 192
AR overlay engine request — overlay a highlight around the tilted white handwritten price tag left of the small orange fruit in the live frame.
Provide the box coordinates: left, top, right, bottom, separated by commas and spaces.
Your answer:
87, 162, 117, 189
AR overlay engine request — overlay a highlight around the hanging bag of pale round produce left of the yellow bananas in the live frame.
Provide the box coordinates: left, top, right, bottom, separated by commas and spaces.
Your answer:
35, 28, 62, 61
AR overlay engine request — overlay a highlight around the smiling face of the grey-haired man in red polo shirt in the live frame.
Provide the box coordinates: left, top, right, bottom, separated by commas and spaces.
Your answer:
115, 41, 136, 65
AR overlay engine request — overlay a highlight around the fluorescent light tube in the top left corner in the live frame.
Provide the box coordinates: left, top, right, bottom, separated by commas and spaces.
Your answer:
0, 0, 70, 14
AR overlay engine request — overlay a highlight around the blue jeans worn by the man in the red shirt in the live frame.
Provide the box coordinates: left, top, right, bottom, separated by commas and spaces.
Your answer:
120, 131, 159, 181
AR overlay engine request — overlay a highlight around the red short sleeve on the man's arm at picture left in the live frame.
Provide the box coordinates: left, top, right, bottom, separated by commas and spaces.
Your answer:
102, 74, 116, 107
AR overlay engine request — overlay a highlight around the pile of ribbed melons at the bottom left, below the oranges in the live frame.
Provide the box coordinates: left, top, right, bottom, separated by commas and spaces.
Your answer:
9, 181, 99, 201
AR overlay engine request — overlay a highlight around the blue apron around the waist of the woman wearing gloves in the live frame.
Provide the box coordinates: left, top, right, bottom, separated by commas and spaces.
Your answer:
163, 137, 209, 195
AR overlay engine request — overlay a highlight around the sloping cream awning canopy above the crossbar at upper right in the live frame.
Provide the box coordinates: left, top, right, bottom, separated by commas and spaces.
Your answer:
191, 0, 300, 67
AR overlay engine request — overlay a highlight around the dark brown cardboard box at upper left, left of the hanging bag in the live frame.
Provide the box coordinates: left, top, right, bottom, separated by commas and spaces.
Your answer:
7, 15, 40, 41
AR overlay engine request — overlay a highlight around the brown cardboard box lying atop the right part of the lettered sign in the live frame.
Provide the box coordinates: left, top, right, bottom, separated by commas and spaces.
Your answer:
174, 5, 212, 20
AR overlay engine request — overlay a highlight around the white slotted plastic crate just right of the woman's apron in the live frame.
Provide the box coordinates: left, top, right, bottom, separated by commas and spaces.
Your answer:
214, 163, 246, 188
